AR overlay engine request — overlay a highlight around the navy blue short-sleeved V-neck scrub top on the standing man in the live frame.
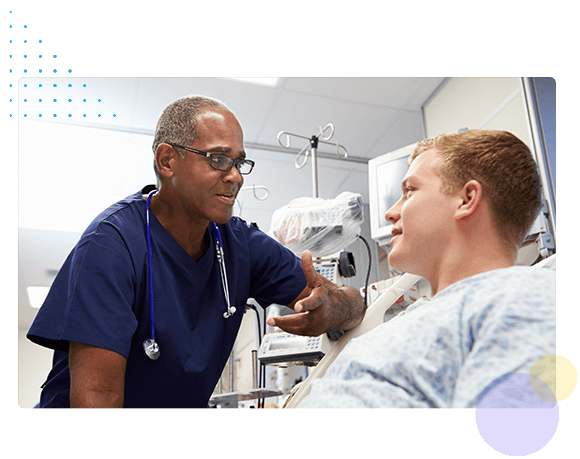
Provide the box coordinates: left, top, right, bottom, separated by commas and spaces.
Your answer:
27, 189, 306, 408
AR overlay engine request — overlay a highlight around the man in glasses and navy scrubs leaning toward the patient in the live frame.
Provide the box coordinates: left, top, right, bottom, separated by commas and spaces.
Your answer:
27, 96, 364, 408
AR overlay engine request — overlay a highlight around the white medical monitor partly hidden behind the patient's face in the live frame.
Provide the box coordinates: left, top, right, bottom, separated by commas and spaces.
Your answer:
369, 143, 417, 247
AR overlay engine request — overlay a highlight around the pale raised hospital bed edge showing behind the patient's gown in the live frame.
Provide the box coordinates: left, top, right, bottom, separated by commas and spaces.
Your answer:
285, 254, 556, 408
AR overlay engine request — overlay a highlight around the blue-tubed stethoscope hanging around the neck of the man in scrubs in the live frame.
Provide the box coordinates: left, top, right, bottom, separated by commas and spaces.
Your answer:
143, 190, 236, 360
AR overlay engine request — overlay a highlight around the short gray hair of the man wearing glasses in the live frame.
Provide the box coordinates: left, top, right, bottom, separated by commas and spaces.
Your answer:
153, 95, 233, 187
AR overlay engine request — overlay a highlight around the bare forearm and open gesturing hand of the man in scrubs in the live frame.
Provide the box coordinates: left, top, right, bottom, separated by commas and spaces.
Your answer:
268, 251, 364, 336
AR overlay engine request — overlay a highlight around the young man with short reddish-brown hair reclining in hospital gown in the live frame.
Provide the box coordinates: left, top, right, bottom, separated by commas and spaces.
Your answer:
299, 130, 556, 408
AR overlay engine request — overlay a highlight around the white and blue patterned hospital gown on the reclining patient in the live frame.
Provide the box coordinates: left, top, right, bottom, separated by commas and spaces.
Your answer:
298, 266, 556, 408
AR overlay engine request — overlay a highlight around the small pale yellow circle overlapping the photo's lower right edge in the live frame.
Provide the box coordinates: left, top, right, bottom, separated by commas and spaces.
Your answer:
530, 354, 578, 402
